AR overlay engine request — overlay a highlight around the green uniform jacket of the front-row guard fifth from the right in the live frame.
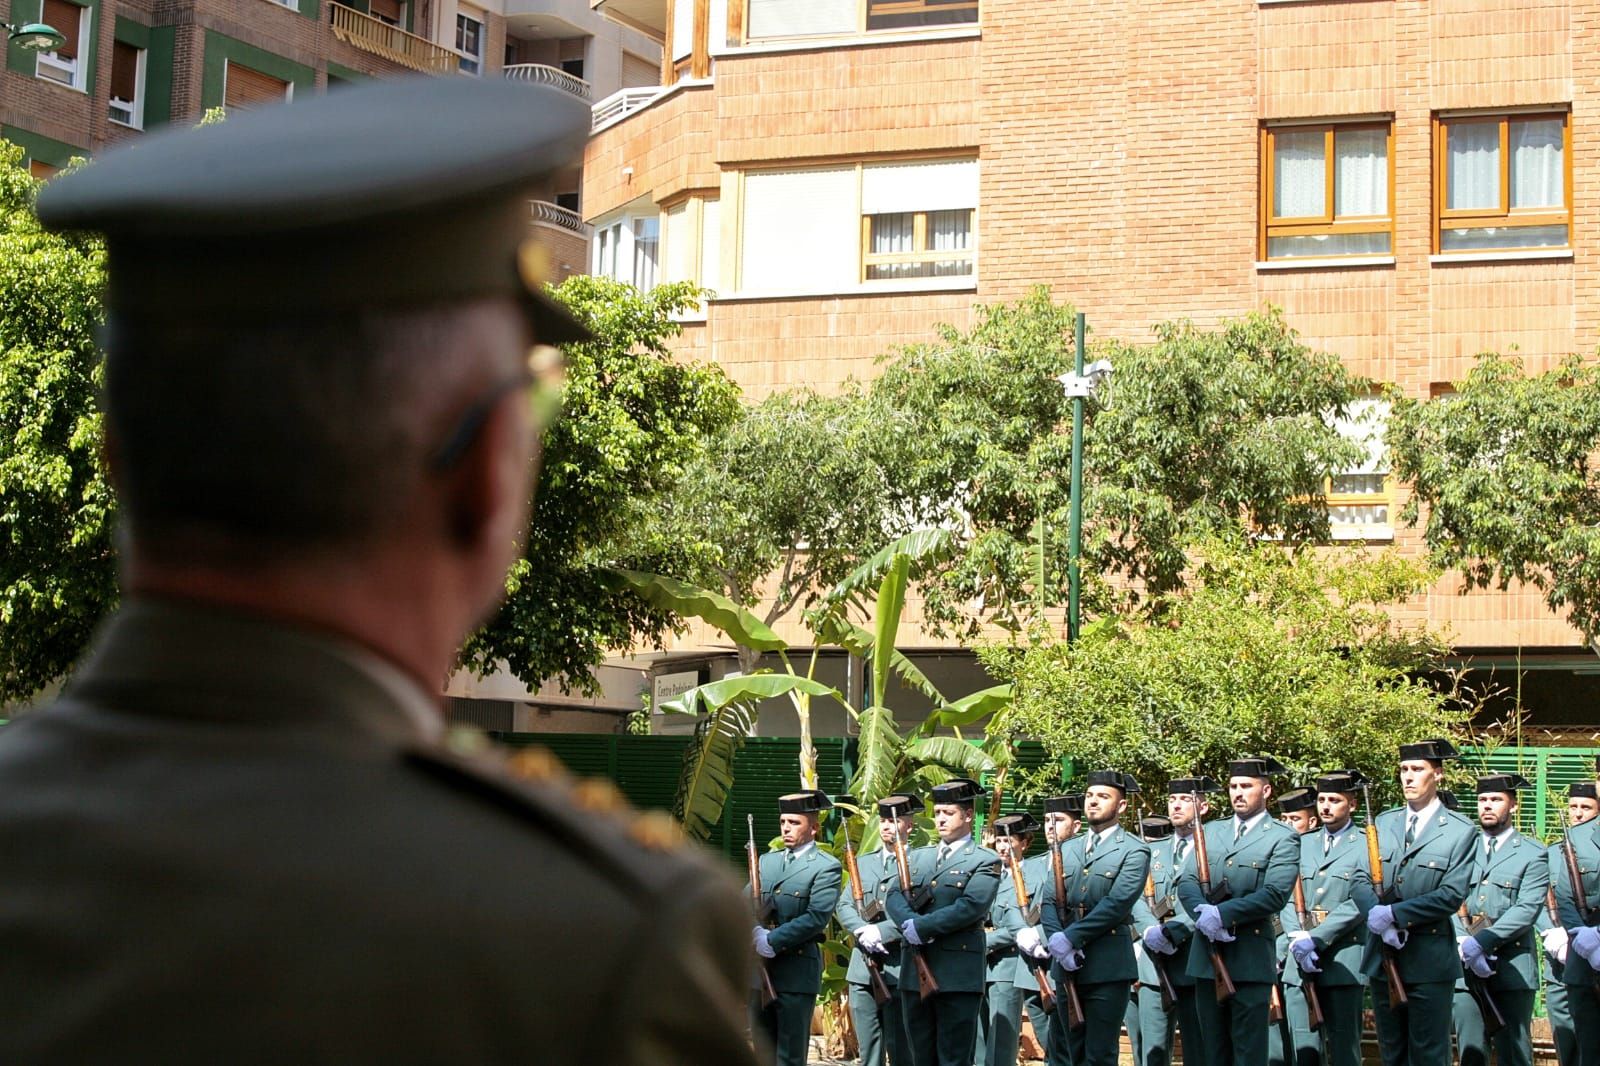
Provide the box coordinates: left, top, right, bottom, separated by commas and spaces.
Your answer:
1178, 818, 1299, 984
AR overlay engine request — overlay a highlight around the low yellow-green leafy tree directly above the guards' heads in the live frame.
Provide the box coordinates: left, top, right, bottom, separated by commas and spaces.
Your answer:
984, 541, 1474, 797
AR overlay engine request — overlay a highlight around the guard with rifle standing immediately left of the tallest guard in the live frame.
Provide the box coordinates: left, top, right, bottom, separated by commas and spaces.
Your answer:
1282, 770, 1376, 1066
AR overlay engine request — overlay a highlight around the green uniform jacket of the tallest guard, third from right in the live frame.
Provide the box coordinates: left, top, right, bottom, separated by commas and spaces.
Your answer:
1362, 805, 1482, 983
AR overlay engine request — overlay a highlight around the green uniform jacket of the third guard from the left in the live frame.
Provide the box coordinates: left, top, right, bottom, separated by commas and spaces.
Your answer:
886, 839, 1000, 992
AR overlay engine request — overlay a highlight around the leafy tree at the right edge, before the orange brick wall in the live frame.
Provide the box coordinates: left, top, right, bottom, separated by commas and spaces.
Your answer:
1387, 355, 1600, 640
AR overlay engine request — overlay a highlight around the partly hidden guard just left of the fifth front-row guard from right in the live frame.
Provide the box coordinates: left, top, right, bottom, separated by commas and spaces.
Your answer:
1133, 776, 1218, 1066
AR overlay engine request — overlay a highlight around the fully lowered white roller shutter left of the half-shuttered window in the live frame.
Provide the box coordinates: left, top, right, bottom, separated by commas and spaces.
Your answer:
739, 166, 861, 291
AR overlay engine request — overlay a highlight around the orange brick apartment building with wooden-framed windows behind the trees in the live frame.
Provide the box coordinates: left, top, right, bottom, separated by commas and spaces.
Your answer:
582, 0, 1600, 727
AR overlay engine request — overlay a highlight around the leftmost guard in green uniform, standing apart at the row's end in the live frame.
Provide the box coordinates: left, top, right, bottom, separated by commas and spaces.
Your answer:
744, 789, 842, 1066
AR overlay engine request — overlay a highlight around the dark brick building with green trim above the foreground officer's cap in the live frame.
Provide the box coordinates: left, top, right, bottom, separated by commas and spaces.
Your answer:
0, 0, 661, 274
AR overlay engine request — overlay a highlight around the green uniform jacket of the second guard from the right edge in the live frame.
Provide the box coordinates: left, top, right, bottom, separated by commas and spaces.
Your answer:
1462, 829, 1550, 991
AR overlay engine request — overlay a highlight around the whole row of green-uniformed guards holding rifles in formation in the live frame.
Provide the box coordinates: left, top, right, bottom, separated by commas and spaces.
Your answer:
746, 739, 1600, 1066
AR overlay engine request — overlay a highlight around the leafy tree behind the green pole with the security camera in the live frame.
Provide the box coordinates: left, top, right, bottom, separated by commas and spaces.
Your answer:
870, 288, 1363, 637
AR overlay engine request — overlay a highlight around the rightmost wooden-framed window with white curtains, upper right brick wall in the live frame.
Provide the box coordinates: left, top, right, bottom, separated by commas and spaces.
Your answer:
1434, 110, 1573, 254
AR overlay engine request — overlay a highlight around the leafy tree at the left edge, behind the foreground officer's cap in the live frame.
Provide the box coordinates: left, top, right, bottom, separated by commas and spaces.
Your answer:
0, 141, 117, 703
